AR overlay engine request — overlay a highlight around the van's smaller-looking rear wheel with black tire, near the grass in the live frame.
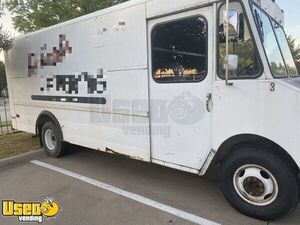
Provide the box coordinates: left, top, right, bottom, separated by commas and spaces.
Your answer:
41, 121, 66, 158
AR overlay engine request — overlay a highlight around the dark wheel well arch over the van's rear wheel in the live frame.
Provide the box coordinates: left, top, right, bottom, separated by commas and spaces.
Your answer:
35, 111, 64, 144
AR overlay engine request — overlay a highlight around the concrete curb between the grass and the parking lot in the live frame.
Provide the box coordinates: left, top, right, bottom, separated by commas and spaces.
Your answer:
0, 149, 46, 172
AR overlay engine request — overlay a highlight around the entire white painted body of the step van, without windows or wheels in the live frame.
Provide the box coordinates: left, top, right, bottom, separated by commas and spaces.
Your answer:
5, 0, 300, 174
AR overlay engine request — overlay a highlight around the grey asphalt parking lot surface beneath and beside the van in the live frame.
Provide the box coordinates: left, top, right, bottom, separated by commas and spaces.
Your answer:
0, 149, 300, 225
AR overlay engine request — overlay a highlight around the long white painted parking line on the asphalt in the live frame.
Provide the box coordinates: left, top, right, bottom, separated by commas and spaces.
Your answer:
31, 160, 220, 225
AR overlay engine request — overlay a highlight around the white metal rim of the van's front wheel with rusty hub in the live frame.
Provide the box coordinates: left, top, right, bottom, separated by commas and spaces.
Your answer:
233, 164, 278, 206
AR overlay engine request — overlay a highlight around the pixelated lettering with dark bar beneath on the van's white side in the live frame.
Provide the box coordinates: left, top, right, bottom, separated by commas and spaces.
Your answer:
28, 34, 107, 104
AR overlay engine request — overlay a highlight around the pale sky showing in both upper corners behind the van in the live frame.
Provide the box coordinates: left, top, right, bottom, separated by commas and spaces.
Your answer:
0, 0, 300, 61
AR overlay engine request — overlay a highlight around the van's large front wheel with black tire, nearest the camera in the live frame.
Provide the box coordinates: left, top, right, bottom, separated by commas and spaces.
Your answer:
219, 146, 300, 220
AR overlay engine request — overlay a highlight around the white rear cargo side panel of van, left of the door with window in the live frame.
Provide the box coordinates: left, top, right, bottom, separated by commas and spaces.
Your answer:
6, 1, 150, 161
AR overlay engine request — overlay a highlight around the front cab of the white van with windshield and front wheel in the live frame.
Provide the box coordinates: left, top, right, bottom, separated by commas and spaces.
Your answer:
212, 1, 300, 219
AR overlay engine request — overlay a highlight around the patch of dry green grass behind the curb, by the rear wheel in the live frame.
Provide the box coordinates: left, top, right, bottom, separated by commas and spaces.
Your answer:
0, 132, 41, 159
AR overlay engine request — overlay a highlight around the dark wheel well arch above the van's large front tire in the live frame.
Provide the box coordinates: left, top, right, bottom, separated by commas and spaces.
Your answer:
214, 134, 300, 174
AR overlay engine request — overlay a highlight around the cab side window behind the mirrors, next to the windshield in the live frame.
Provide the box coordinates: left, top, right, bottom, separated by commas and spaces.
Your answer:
218, 2, 262, 79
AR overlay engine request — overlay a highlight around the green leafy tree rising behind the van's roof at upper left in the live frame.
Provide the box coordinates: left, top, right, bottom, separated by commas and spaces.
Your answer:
5, 0, 127, 33
